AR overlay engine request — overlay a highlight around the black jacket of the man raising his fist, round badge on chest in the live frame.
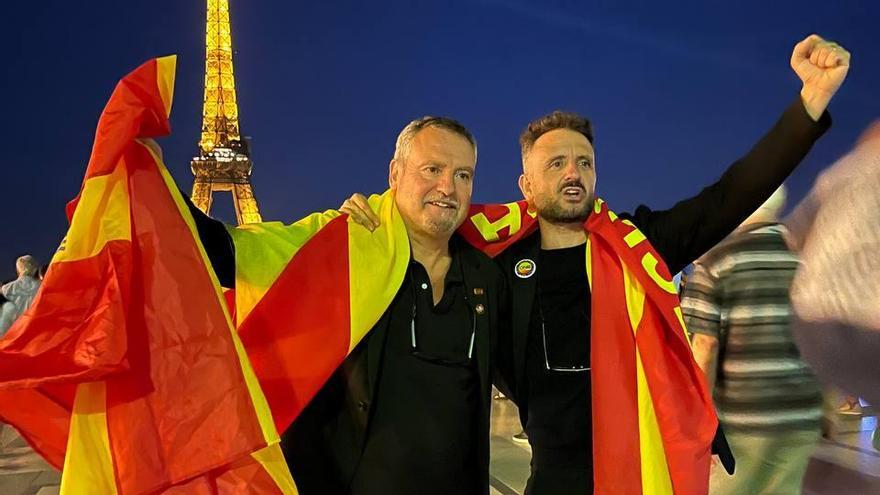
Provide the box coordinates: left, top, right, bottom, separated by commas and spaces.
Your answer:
496, 97, 831, 471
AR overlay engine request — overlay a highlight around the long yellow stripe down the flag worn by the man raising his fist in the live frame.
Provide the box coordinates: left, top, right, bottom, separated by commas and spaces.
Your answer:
621, 264, 672, 495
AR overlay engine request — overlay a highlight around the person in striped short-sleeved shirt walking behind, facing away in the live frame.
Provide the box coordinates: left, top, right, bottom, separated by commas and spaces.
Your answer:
681, 187, 822, 495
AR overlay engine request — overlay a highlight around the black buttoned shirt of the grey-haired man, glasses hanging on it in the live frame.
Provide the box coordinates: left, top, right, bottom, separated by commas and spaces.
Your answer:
351, 251, 480, 495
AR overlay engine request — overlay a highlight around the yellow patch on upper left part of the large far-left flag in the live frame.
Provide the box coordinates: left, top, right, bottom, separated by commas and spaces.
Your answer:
52, 160, 131, 263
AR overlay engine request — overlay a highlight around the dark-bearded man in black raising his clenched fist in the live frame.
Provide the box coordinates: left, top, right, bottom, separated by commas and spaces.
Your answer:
345, 35, 849, 495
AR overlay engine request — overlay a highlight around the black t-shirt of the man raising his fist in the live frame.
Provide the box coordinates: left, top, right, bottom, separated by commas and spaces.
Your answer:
526, 244, 592, 469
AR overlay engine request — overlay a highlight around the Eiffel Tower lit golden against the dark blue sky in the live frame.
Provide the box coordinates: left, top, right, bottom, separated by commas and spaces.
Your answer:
190, 0, 262, 225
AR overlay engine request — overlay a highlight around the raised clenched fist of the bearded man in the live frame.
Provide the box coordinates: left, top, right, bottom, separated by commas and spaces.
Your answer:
791, 34, 850, 121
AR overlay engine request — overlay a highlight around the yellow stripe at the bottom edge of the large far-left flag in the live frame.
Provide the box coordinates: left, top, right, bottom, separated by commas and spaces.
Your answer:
61, 382, 116, 495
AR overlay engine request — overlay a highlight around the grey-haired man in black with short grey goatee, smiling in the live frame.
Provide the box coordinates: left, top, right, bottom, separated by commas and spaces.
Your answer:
190, 117, 508, 495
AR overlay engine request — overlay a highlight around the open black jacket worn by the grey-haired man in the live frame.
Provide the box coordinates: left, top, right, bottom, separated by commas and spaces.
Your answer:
281, 236, 509, 495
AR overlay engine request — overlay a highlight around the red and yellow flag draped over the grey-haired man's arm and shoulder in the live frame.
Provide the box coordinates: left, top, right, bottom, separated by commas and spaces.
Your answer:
223, 191, 410, 434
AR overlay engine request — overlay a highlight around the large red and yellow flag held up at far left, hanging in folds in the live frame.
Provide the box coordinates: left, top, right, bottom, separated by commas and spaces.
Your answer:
0, 57, 295, 494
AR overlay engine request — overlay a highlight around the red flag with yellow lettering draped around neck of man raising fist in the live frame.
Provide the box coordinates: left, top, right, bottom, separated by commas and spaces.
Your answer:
459, 199, 718, 495
